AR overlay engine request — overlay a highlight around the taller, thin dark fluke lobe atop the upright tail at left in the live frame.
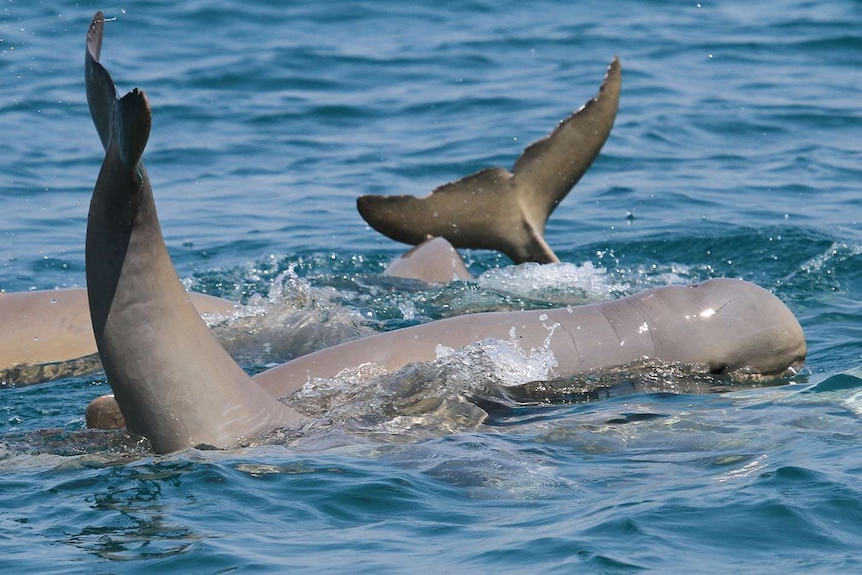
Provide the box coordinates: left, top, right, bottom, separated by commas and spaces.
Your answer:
84, 11, 117, 150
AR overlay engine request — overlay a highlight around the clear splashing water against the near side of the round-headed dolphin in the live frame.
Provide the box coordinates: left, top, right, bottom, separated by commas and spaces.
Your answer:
291, 340, 556, 441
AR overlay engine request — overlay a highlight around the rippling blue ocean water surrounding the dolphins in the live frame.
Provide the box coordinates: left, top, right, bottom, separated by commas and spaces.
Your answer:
0, 0, 862, 574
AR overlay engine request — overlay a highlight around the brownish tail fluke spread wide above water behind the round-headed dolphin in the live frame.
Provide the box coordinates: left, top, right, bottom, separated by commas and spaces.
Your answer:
356, 58, 622, 263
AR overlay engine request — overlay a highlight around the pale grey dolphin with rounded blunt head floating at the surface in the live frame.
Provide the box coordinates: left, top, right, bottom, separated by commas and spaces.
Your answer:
255, 279, 806, 397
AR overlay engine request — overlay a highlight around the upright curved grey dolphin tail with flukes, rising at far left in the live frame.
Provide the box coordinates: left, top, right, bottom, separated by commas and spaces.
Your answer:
86, 12, 305, 452
